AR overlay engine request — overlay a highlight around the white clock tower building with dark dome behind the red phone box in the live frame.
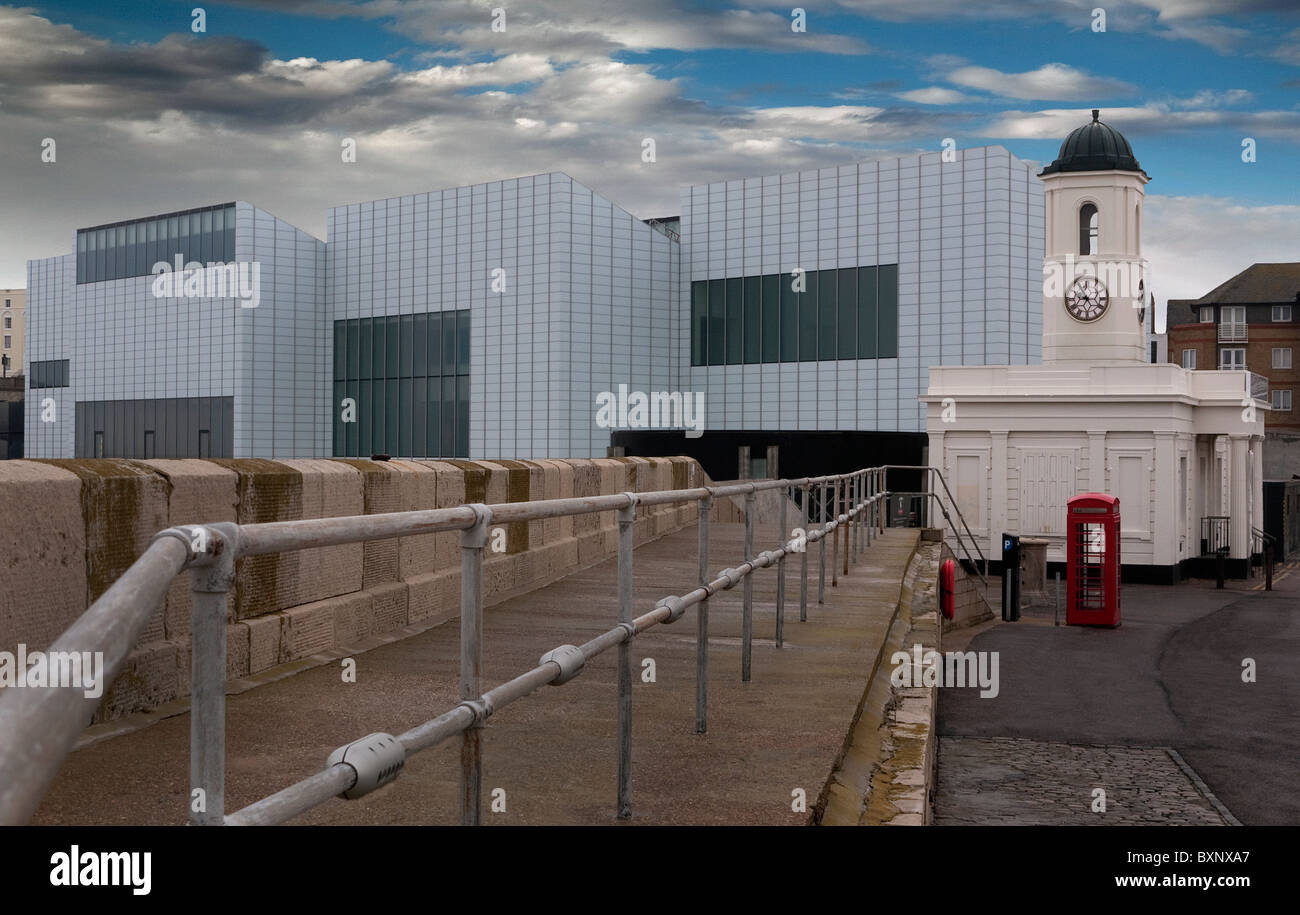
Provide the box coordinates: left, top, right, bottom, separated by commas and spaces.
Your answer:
922, 110, 1268, 581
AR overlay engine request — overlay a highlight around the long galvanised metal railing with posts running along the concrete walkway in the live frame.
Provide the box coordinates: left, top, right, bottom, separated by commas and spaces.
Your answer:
0, 465, 935, 825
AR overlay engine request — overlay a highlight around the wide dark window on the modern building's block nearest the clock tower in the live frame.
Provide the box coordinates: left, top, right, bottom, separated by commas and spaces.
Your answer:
690, 264, 898, 365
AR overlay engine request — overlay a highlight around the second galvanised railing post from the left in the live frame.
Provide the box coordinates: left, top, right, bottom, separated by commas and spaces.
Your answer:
460, 503, 491, 827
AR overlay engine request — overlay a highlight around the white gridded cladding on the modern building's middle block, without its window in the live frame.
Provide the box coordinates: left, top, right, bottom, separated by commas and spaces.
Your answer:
325, 173, 684, 459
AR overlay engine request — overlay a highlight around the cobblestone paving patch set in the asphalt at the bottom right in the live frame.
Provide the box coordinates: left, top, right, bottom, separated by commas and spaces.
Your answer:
935, 737, 1226, 825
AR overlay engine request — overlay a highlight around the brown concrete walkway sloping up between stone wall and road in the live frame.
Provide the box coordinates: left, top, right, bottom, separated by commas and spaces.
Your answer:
33, 522, 918, 825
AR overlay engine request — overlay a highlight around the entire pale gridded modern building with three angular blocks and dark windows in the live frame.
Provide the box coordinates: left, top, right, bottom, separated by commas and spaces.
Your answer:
26, 147, 1044, 478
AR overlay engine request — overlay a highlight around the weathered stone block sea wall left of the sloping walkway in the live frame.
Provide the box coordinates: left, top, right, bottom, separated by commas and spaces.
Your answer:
0, 458, 707, 720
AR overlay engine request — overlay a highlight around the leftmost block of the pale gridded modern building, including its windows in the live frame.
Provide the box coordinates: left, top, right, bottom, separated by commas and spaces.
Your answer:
23, 203, 329, 458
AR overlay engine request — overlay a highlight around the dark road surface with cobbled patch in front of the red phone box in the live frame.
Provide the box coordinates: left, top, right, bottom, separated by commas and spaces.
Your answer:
935, 553, 1300, 825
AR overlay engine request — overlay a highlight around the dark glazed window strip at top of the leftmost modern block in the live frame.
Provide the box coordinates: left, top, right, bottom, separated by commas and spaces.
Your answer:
77, 203, 235, 283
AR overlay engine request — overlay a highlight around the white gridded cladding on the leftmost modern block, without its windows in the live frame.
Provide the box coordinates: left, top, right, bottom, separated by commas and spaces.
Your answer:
25, 203, 330, 458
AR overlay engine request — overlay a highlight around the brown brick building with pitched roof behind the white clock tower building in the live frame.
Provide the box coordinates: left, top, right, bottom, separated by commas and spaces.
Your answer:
1166, 263, 1300, 480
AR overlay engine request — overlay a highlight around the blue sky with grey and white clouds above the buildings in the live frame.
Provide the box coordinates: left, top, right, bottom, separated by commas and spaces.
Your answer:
0, 0, 1300, 332
